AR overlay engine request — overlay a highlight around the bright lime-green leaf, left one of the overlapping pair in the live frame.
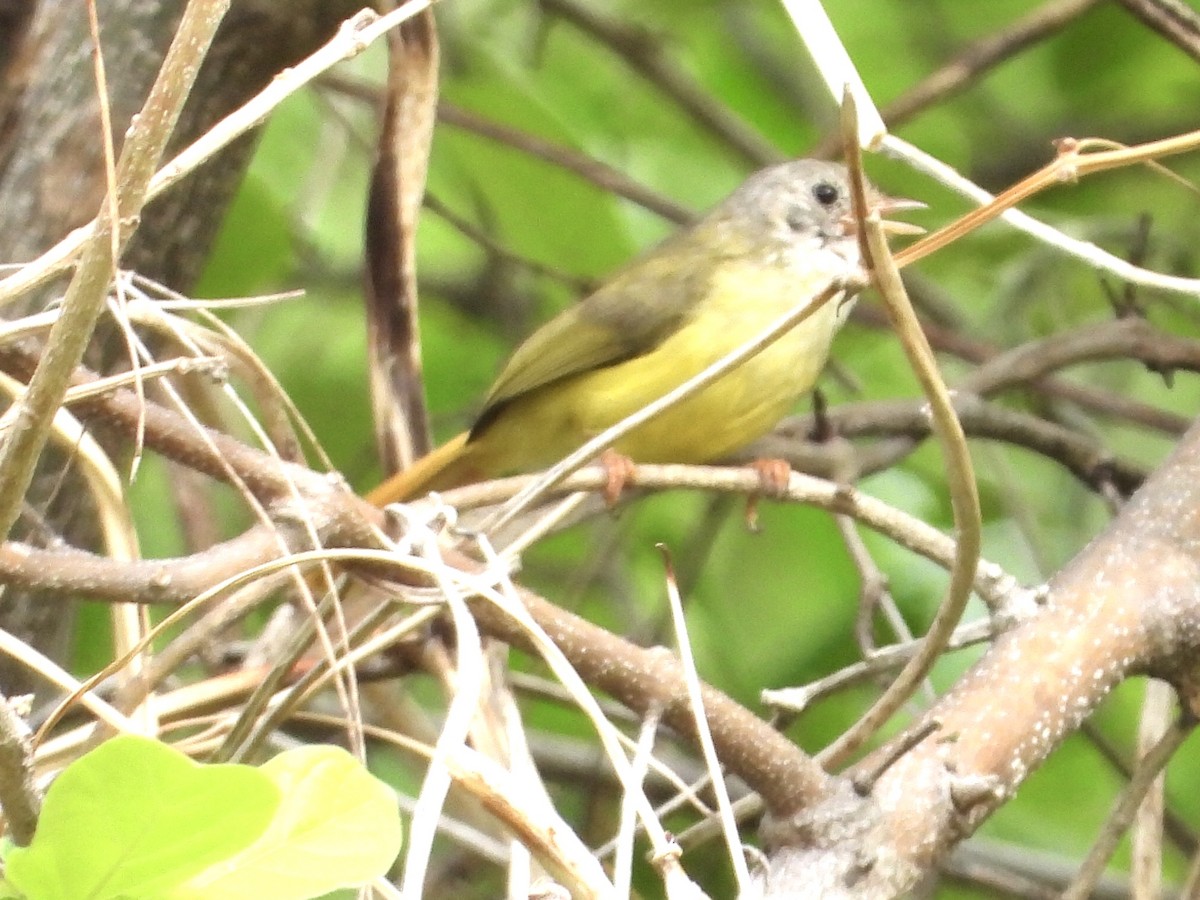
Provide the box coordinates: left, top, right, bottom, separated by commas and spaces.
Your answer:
5, 736, 280, 900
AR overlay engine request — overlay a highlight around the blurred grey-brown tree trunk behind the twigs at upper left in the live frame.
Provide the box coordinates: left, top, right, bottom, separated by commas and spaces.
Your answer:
0, 0, 362, 690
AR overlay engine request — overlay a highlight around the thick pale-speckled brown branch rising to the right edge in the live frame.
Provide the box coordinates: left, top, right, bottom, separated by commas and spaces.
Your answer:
755, 422, 1200, 898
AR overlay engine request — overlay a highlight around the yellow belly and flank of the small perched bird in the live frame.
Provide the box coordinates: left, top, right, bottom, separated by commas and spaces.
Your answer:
480, 283, 845, 472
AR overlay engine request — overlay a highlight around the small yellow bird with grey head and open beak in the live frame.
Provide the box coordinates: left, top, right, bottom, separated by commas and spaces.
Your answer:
368, 160, 924, 506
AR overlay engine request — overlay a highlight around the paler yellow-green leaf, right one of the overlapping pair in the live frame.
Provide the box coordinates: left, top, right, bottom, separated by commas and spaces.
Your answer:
168, 746, 401, 900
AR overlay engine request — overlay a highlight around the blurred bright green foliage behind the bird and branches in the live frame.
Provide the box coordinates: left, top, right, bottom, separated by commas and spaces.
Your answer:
112, 0, 1200, 896
